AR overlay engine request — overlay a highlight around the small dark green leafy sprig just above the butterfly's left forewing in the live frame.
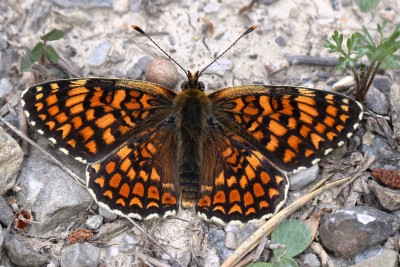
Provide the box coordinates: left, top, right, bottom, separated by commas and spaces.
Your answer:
20, 29, 64, 82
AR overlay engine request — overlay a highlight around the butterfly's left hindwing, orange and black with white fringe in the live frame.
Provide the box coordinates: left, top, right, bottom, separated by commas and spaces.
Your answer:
86, 124, 179, 219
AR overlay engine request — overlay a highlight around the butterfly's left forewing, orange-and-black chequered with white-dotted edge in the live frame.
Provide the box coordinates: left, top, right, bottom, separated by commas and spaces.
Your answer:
22, 78, 176, 162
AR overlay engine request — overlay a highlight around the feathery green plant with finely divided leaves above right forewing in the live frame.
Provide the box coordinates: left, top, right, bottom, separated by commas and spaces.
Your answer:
324, 22, 400, 101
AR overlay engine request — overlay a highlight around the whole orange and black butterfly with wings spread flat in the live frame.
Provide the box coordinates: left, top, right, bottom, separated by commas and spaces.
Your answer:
22, 27, 363, 226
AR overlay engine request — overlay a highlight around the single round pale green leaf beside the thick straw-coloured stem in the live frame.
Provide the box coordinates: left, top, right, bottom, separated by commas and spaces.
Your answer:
271, 220, 311, 258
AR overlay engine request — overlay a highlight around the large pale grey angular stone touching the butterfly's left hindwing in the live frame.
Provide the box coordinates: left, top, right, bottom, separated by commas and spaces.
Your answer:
17, 140, 92, 237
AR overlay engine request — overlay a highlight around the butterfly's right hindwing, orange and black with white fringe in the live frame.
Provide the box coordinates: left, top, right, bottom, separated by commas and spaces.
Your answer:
196, 126, 289, 223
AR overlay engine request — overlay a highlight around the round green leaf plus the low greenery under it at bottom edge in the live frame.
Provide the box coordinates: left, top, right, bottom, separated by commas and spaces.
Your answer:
249, 220, 312, 267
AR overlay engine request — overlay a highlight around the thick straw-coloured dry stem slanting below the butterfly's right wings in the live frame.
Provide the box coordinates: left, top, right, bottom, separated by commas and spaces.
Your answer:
221, 158, 375, 267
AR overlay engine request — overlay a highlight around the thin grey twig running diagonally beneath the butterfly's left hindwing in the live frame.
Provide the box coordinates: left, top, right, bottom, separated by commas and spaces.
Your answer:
0, 116, 182, 266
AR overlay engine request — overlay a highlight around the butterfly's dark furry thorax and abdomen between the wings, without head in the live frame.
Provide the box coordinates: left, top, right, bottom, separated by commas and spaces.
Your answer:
175, 90, 210, 208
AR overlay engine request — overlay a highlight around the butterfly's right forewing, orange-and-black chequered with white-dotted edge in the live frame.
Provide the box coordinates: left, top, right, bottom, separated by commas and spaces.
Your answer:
209, 85, 363, 172
